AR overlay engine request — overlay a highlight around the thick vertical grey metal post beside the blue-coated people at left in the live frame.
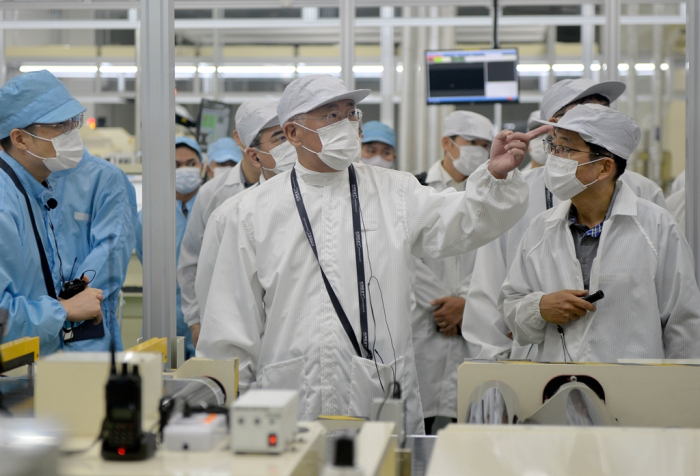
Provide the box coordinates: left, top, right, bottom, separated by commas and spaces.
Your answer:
137, 0, 176, 366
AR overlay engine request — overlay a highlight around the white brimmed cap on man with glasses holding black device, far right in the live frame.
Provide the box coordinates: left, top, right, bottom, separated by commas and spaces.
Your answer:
539, 104, 642, 160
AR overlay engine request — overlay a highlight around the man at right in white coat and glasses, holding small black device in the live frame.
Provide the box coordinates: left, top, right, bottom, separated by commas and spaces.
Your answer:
500, 104, 700, 362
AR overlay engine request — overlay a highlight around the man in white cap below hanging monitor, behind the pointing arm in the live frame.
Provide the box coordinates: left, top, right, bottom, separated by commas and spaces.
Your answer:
412, 111, 493, 434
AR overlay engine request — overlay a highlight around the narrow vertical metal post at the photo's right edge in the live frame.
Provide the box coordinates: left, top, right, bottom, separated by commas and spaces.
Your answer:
685, 1, 700, 279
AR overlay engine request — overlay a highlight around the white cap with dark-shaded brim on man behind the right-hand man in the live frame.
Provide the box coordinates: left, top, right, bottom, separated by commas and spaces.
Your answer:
540, 78, 627, 121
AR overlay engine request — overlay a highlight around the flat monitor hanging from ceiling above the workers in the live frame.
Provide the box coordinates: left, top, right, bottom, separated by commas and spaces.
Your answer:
425, 49, 519, 104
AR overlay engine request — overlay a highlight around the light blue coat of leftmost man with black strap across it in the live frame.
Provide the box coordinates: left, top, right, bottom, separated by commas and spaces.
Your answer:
0, 151, 66, 356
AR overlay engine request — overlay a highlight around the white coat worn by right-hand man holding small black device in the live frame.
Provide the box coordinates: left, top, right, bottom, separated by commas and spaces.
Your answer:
499, 183, 700, 362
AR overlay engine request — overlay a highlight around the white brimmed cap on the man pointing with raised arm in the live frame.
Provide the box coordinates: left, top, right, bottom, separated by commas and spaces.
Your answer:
277, 74, 371, 126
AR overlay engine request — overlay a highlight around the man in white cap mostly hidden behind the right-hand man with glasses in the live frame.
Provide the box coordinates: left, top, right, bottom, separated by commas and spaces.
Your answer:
462, 79, 665, 359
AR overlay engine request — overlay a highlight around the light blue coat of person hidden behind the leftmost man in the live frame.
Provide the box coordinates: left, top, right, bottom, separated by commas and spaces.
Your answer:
49, 149, 138, 352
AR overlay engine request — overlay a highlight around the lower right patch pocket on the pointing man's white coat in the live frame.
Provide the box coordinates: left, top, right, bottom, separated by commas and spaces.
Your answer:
348, 355, 406, 418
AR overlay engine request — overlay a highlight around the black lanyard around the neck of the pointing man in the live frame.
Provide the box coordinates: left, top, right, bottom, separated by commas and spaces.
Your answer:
291, 165, 372, 358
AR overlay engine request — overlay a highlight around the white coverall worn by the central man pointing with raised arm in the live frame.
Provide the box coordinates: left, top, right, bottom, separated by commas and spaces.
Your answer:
197, 163, 527, 434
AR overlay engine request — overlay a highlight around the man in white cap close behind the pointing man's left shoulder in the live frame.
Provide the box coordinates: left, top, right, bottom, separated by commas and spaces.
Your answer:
178, 100, 296, 347
